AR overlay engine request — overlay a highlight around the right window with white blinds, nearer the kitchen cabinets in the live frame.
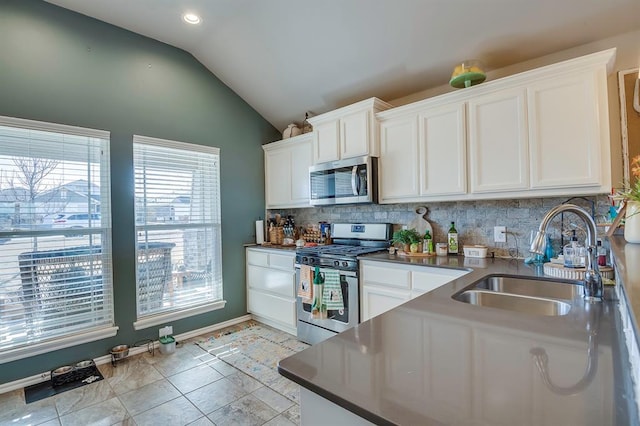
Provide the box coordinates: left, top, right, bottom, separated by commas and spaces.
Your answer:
133, 136, 224, 329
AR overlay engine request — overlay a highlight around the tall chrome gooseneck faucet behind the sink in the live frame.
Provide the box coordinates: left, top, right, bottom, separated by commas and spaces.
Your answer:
530, 204, 603, 302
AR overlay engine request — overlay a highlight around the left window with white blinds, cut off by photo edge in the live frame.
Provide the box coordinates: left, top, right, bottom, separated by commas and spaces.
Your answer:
0, 117, 117, 362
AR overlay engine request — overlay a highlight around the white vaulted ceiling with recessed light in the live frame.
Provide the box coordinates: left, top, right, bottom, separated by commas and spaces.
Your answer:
47, 0, 640, 130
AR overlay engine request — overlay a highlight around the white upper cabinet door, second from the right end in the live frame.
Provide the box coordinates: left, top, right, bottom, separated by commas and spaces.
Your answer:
469, 88, 529, 193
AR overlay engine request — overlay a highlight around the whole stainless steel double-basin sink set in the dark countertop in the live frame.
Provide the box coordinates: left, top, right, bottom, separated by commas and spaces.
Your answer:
453, 275, 583, 316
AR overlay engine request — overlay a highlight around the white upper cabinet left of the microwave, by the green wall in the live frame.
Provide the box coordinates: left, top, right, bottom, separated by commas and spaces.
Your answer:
262, 133, 313, 209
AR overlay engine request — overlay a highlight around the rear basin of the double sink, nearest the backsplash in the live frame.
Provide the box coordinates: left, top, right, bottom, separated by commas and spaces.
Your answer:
473, 276, 583, 300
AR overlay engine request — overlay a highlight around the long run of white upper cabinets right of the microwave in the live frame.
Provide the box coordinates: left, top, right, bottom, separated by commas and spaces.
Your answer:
376, 49, 615, 203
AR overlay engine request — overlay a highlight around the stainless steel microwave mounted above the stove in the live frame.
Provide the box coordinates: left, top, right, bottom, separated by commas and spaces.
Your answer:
309, 156, 378, 206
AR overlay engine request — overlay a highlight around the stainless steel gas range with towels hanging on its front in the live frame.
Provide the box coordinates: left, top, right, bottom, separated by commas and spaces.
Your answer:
295, 223, 392, 344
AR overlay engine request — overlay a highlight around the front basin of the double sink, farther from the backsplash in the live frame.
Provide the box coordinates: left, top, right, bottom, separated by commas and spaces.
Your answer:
454, 290, 571, 316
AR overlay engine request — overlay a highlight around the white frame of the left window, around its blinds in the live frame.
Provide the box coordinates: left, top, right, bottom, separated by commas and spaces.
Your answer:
0, 116, 118, 364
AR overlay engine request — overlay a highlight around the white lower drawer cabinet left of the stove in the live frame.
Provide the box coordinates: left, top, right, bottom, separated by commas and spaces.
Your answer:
246, 248, 297, 334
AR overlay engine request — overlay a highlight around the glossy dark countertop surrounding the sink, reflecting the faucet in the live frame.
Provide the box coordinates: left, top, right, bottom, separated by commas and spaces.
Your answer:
278, 243, 640, 425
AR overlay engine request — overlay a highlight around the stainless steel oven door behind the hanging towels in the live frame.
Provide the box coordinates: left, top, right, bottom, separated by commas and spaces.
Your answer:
296, 266, 360, 333
